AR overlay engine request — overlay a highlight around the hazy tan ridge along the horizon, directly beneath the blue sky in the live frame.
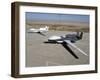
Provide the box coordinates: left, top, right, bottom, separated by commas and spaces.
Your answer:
26, 20, 89, 27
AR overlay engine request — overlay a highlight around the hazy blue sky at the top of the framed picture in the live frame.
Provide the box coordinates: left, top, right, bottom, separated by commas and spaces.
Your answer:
26, 12, 89, 22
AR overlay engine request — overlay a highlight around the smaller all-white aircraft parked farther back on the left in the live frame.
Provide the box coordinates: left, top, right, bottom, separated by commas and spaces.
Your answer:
28, 26, 49, 36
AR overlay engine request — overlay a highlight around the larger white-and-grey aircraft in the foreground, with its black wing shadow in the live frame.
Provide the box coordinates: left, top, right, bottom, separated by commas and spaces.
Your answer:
45, 32, 88, 59
